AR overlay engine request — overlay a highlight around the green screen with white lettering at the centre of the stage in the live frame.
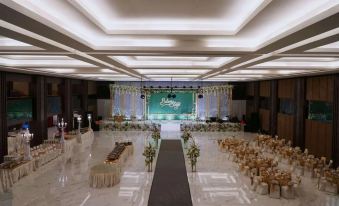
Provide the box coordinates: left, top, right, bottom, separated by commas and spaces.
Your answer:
148, 91, 195, 120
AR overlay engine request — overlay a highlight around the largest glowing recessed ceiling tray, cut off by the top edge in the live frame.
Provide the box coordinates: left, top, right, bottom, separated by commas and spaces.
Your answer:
70, 0, 271, 35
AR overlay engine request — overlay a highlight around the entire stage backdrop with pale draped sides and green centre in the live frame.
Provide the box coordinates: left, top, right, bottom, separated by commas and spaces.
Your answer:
110, 83, 233, 120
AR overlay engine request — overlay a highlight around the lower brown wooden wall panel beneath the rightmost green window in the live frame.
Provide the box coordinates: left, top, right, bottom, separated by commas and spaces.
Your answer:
305, 120, 332, 159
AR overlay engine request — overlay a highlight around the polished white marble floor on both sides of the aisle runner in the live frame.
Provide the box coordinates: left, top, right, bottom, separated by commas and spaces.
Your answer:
0, 131, 339, 206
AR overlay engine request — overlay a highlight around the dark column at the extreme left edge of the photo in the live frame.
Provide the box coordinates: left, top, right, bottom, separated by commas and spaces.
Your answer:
0, 71, 8, 163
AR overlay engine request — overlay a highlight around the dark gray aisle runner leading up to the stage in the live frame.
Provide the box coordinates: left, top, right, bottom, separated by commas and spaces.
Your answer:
148, 140, 192, 206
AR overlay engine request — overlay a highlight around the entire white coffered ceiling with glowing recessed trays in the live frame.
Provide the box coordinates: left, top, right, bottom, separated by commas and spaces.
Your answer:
0, 0, 339, 81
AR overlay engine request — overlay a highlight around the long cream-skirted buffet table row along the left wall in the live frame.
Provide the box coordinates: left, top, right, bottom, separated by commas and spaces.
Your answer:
0, 130, 94, 193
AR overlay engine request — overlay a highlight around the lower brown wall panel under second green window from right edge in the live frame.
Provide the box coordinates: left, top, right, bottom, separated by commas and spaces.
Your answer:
277, 113, 294, 142
